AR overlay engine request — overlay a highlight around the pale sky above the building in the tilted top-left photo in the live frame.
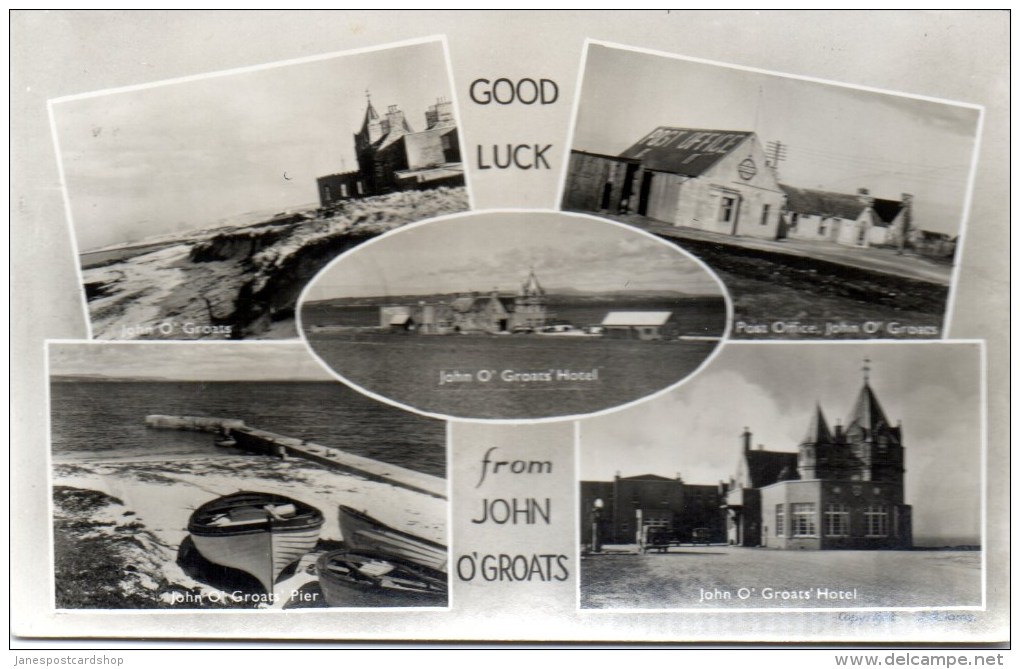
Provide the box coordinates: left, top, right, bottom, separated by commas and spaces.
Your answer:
53, 41, 451, 251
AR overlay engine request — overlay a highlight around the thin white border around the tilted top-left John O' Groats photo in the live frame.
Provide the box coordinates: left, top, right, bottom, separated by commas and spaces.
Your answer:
46, 35, 475, 342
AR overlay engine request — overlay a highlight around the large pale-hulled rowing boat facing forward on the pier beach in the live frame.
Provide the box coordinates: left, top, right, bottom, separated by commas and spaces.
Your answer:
188, 492, 323, 593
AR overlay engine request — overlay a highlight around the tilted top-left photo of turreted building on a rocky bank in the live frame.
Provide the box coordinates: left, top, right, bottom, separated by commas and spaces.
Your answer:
50, 39, 469, 340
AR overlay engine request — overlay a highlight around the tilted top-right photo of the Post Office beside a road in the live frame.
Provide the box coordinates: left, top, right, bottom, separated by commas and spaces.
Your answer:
561, 42, 981, 340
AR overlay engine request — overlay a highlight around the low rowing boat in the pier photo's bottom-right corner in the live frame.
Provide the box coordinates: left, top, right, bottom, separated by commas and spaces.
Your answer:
315, 551, 448, 608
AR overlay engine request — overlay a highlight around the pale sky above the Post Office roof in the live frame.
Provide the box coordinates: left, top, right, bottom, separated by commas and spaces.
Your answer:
571, 44, 979, 235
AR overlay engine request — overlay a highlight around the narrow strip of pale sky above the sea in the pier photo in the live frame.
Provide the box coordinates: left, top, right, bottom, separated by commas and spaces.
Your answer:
49, 342, 334, 381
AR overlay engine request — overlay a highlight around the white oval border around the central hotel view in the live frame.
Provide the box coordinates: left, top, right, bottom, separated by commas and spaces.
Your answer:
295, 208, 733, 425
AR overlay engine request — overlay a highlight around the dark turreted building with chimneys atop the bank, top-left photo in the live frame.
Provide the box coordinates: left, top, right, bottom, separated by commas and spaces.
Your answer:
317, 92, 464, 207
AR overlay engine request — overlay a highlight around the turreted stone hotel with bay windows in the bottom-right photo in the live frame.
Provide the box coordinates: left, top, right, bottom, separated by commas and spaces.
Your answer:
725, 367, 913, 550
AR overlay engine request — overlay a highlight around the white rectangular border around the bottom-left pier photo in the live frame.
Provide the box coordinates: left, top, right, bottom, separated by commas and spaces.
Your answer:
44, 340, 454, 616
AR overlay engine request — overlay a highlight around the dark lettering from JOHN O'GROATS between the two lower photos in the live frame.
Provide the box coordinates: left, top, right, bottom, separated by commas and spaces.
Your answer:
456, 446, 570, 582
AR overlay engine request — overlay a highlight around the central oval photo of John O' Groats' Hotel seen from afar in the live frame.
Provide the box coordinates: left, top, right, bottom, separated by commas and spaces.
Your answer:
299, 211, 728, 419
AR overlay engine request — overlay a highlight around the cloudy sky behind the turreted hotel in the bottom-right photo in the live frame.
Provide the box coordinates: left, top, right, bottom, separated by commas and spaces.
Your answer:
580, 342, 982, 544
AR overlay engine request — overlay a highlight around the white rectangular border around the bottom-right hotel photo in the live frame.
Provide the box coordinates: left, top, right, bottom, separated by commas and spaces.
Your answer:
575, 340, 988, 615
